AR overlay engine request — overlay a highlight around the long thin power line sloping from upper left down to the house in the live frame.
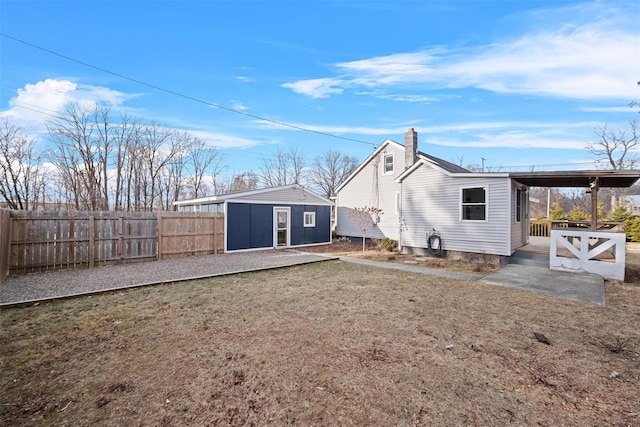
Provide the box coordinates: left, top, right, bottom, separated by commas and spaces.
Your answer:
0, 32, 377, 147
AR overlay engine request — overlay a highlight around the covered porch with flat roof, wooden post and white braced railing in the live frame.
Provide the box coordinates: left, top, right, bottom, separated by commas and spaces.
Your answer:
510, 171, 640, 280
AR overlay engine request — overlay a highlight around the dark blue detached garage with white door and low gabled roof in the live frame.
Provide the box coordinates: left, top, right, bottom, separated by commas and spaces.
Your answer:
173, 185, 333, 252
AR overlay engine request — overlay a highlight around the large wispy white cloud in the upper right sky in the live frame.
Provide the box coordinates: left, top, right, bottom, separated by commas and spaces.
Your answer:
282, 2, 640, 101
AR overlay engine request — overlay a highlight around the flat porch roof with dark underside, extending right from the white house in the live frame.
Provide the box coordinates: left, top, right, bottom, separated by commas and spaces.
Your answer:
509, 170, 640, 188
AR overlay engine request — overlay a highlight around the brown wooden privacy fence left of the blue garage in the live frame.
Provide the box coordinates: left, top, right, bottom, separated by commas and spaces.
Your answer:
0, 210, 224, 280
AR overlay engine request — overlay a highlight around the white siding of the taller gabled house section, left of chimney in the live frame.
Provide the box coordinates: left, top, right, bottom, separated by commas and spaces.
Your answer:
336, 144, 405, 240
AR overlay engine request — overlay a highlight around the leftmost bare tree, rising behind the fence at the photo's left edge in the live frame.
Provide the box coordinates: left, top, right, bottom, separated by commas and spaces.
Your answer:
0, 118, 43, 210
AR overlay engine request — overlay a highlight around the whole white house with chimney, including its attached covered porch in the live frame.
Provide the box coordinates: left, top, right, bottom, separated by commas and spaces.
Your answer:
336, 129, 640, 279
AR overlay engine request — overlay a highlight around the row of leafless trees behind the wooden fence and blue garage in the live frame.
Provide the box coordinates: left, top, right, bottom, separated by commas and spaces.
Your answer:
0, 104, 358, 211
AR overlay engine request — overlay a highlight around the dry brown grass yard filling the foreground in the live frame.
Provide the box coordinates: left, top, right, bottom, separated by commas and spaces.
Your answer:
0, 251, 640, 426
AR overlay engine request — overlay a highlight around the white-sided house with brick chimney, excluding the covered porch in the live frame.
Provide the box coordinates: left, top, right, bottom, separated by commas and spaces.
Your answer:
336, 129, 529, 256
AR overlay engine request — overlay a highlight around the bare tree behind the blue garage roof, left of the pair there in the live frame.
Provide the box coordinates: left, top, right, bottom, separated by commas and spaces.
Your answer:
260, 145, 305, 187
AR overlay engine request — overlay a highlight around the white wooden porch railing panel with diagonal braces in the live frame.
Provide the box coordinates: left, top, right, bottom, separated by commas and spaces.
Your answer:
549, 229, 626, 280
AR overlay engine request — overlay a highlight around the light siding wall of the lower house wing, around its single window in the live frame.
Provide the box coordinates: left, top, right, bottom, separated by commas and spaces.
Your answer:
400, 165, 513, 255
